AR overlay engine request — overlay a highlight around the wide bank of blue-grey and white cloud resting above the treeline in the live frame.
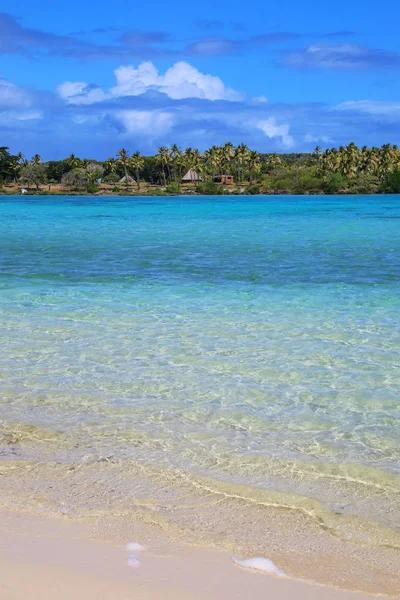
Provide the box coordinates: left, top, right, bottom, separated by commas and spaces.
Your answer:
0, 57, 400, 159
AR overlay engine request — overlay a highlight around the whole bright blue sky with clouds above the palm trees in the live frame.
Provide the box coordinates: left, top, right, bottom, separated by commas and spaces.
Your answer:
0, 0, 400, 160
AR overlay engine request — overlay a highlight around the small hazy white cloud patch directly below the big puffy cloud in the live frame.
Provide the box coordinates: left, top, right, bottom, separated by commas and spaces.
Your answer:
115, 110, 175, 137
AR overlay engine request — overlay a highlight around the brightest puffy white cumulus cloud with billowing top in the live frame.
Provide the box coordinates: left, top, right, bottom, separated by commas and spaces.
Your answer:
57, 62, 242, 104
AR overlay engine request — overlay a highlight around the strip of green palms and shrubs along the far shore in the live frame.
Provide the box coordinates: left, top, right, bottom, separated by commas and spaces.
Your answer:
0, 142, 400, 195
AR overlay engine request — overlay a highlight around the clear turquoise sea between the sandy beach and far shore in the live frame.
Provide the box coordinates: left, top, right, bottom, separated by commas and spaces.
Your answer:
0, 196, 400, 584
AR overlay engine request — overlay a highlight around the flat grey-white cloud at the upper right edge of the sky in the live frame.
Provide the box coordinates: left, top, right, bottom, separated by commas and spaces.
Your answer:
284, 44, 400, 70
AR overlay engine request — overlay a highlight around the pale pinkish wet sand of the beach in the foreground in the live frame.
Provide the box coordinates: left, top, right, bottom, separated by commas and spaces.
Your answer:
0, 512, 384, 600
